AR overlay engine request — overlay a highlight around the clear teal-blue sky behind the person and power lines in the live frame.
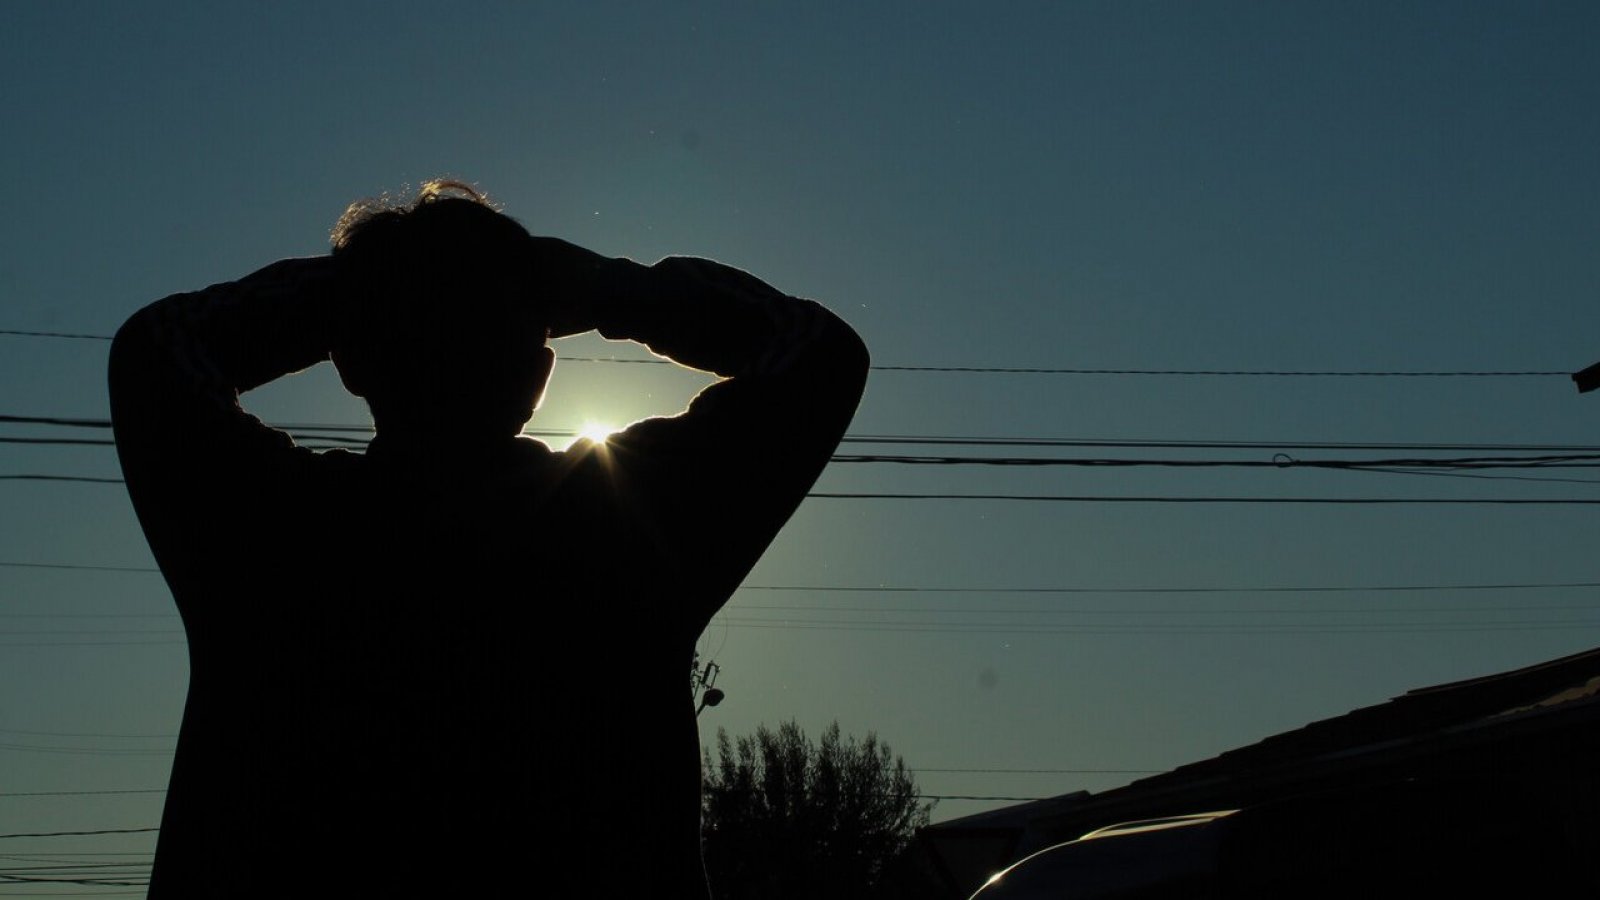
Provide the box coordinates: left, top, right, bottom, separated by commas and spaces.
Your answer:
0, 0, 1600, 892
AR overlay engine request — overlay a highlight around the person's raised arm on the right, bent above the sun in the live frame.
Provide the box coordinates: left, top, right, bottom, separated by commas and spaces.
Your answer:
534, 237, 869, 618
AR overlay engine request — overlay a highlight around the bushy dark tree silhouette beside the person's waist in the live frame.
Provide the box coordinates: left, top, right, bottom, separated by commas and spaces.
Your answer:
702, 721, 933, 900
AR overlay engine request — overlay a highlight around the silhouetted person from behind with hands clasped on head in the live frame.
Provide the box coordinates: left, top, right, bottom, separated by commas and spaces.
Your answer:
110, 184, 867, 898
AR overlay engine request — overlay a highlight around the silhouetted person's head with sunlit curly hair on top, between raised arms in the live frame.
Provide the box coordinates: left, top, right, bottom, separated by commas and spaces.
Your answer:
333, 181, 554, 439
